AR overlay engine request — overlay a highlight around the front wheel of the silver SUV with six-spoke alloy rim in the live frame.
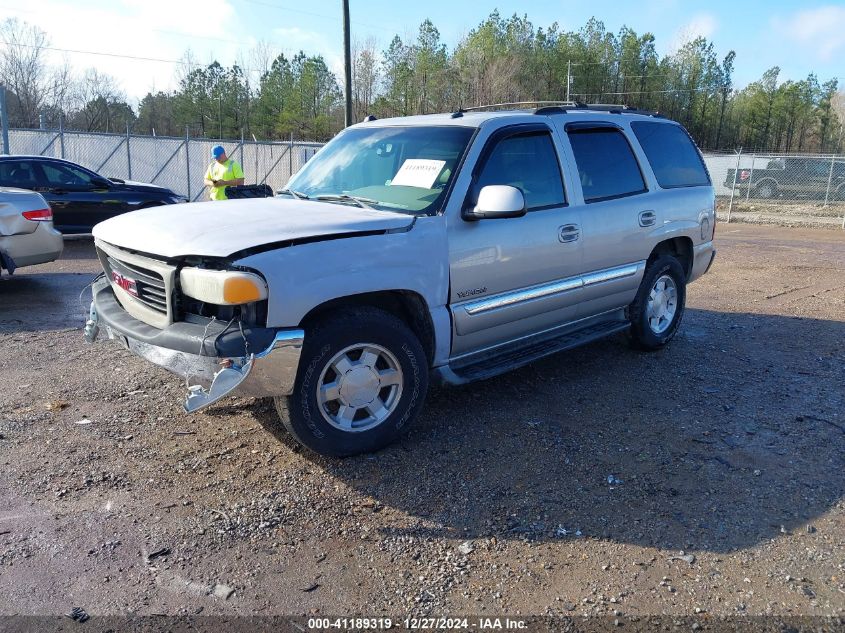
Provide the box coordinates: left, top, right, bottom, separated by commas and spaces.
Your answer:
275, 307, 428, 457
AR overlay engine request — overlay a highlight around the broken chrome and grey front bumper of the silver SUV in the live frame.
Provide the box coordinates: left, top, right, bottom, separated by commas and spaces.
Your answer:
85, 278, 305, 413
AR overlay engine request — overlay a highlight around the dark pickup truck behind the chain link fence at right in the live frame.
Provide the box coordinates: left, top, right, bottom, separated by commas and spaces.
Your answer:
724, 156, 845, 201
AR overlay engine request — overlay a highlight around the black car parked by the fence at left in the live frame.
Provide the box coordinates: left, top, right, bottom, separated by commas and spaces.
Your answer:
0, 156, 187, 233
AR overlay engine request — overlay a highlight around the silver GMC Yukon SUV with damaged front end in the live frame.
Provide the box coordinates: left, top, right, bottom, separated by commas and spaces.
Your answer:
86, 103, 716, 456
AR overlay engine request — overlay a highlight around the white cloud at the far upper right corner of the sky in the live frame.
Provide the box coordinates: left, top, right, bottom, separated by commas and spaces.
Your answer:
772, 5, 845, 62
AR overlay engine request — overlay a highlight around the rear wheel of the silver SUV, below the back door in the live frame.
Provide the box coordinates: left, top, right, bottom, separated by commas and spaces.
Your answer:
628, 255, 687, 351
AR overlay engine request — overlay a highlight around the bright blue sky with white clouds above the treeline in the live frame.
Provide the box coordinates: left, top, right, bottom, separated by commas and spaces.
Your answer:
0, 0, 845, 101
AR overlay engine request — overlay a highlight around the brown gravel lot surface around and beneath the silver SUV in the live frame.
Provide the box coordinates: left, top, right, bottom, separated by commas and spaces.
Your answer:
0, 224, 845, 617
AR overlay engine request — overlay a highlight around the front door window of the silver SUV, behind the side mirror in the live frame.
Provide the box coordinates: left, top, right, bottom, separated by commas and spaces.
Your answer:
476, 132, 566, 211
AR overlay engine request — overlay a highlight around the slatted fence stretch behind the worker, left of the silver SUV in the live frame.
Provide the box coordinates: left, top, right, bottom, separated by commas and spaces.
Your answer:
9, 129, 322, 201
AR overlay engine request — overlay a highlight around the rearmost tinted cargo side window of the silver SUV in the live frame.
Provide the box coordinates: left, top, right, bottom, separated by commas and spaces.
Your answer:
631, 121, 710, 189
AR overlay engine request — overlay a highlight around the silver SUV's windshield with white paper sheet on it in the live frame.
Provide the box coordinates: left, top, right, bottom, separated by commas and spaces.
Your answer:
285, 126, 473, 214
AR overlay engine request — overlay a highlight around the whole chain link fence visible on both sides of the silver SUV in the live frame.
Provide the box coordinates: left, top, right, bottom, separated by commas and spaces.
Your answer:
3, 129, 845, 229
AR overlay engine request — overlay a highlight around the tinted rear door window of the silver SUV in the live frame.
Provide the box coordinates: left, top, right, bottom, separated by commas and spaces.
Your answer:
567, 127, 646, 202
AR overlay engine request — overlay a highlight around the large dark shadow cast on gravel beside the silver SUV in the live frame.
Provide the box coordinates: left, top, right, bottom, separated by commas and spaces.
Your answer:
254, 310, 845, 552
